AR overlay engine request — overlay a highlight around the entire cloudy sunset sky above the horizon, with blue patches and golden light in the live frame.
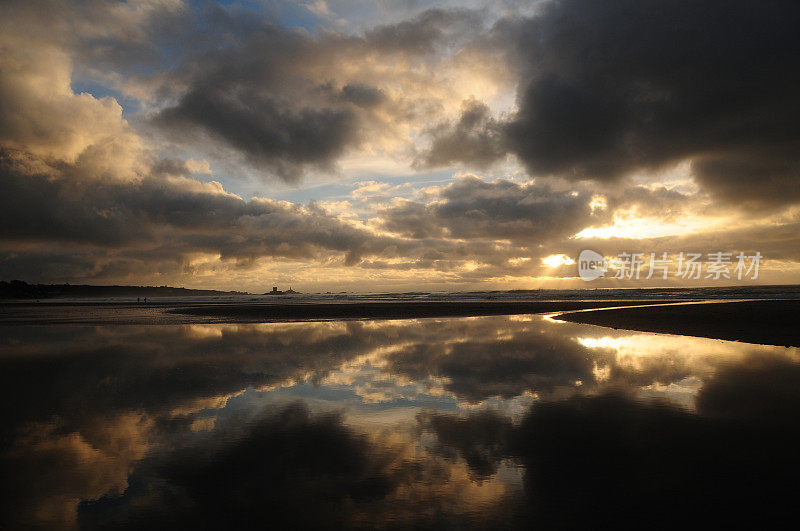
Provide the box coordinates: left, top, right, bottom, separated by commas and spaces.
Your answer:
0, 0, 800, 293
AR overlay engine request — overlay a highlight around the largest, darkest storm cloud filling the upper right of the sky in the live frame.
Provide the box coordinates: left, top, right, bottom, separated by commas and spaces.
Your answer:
424, 0, 800, 206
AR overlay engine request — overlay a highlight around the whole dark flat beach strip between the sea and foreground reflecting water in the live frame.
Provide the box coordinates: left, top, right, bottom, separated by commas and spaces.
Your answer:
0, 299, 800, 352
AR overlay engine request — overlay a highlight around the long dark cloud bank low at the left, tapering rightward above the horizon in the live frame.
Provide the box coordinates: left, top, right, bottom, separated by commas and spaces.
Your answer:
0, 149, 404, 268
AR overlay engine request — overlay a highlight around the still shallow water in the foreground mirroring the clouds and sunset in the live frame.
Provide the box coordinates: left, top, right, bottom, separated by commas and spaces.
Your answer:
0, 315, 800, 528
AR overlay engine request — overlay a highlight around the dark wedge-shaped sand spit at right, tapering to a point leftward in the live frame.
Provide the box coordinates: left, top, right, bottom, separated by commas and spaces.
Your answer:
557, 300, 800, 347
